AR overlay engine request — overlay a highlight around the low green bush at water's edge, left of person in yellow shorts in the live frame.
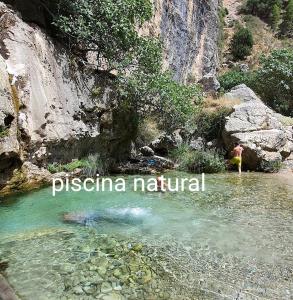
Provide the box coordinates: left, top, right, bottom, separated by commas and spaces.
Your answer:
171, 144, 226, 173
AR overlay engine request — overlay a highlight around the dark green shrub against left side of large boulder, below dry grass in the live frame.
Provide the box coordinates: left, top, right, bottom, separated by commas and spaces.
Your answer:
193, 107, 231, 141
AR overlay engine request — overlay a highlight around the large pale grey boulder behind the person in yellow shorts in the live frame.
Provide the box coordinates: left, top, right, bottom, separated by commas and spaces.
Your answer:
222, 85, 293, 170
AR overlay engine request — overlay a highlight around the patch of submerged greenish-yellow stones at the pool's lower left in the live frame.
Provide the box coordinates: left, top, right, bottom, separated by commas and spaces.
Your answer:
1, 230, 180, 300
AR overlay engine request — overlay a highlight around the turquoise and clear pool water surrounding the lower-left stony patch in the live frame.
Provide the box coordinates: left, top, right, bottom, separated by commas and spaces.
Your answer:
0, 173, 293, 299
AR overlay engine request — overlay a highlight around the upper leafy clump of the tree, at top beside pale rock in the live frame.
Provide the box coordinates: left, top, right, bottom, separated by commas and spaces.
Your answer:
54, 0, 155, 70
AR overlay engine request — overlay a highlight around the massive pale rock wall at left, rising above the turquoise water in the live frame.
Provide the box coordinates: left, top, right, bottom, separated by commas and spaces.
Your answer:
0, 2, 135, 187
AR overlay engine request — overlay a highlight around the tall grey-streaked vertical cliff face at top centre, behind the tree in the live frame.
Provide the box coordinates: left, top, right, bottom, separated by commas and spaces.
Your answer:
141, 0, 220, 83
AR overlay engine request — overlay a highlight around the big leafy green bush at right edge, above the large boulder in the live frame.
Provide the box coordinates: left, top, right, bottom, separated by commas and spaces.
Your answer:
252, 49, 293, 116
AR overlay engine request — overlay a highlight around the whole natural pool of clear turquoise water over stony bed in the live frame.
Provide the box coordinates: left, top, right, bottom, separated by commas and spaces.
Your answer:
0, 172, 293, 300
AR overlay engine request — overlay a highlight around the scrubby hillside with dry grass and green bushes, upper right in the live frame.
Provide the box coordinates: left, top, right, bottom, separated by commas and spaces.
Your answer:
219, 0, 293, 116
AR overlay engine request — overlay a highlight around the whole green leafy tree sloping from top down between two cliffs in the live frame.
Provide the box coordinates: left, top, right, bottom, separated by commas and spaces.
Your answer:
54, 0, 202, 130
